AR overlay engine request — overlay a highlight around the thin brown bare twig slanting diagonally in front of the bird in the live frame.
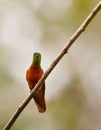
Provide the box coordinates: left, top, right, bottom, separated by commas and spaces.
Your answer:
3, 1, 101, 130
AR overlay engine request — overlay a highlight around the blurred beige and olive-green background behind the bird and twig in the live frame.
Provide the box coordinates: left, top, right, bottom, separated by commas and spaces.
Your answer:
0, 0, 101, 130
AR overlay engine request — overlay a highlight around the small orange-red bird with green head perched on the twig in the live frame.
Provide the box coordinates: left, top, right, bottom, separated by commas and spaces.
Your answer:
26, 52, 46, 113
